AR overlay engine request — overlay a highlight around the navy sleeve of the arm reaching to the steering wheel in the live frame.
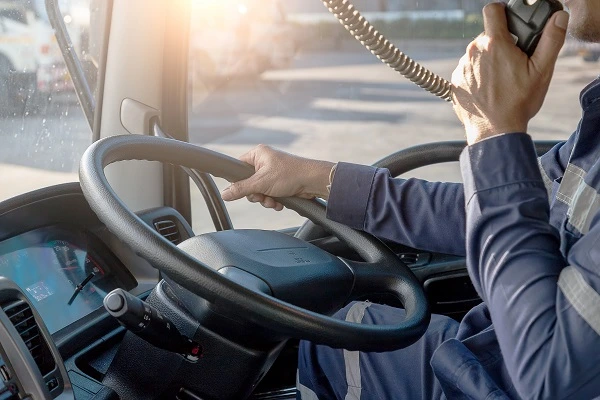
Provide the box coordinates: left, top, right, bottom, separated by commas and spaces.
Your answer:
327, 163, 465, 256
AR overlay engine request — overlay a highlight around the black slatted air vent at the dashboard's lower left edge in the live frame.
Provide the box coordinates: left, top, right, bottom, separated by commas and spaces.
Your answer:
2, 300, 56, 375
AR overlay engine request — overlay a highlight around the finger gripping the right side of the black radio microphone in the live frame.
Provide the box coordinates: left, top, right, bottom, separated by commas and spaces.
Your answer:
531, 11, 569, 73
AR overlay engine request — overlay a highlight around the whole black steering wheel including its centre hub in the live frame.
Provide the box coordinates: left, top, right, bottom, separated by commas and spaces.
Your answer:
79, 135, 430, 351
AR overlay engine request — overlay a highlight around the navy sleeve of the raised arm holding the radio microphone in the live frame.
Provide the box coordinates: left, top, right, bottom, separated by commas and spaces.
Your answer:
461, 133, 600, 399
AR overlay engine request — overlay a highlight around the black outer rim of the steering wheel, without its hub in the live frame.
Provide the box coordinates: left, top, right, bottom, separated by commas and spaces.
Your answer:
79, 135, 430, 351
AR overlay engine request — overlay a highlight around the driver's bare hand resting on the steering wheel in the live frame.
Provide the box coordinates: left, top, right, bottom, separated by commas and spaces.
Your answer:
221, 145, 334, 211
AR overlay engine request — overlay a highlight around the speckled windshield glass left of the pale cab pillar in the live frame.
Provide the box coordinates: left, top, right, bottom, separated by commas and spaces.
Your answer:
0, 0, 92, 200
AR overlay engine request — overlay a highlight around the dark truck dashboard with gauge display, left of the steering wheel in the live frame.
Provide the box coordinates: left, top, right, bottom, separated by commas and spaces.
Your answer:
0, 183, 193, 400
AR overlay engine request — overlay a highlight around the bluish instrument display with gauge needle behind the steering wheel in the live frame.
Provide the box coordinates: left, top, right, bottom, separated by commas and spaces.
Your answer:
0, 228, 135, 334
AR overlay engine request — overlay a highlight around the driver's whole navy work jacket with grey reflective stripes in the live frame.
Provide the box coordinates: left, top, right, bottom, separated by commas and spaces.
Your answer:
327, 80, 600, 399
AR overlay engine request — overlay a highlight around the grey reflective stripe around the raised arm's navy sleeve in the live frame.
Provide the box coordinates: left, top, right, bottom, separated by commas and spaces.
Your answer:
558, 267, 600, 335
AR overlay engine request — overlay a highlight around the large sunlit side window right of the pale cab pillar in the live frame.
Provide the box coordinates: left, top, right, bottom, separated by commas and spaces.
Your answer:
189, 0, 584, 232
